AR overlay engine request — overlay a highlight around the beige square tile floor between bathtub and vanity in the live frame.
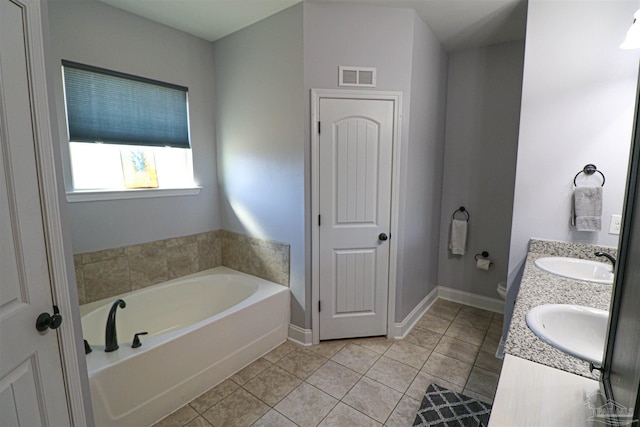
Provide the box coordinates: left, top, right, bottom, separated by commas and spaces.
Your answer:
154, 299, 502, 427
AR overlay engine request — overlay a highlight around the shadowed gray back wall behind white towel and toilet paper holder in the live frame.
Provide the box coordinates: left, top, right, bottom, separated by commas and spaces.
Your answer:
438, 41, 524, 298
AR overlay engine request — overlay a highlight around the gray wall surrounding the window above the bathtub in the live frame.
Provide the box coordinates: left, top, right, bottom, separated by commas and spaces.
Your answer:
49, 0, 221, 253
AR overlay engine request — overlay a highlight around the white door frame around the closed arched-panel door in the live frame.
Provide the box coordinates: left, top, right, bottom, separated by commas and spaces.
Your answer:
310, 89, 402, 344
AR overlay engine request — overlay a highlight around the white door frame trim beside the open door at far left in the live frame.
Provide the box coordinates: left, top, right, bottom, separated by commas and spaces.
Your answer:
2, 0, 93, 427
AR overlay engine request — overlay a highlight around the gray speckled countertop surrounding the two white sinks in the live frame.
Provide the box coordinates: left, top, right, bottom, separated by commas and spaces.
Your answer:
505, 239, 616, 379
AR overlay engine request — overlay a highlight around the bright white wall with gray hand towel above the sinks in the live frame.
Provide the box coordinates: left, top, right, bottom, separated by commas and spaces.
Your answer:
509, 0, 638, 285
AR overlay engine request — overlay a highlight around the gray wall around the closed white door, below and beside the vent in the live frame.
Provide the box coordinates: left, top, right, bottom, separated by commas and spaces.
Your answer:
304, 2, 446, 324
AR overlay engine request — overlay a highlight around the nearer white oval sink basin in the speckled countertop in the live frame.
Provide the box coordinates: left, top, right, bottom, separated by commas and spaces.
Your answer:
527, 304, 609, 365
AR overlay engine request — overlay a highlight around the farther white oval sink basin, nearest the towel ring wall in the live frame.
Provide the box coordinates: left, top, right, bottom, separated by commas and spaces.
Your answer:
534, 257, 613, 284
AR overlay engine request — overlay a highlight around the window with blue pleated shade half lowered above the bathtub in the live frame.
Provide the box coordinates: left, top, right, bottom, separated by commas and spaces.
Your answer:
62, 61, 194, 195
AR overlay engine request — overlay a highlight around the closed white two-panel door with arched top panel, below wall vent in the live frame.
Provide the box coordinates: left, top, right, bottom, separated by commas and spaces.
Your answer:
319, 98, 394, 340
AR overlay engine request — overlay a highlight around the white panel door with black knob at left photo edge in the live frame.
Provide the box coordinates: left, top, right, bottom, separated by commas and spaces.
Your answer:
0, 0, 71, 427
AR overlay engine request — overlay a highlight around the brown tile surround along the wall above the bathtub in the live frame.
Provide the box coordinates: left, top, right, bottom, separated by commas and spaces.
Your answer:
73, 230, 289, 304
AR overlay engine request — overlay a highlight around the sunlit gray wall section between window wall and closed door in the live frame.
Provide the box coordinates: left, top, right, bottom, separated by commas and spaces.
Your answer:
211, 4, 309, 326
